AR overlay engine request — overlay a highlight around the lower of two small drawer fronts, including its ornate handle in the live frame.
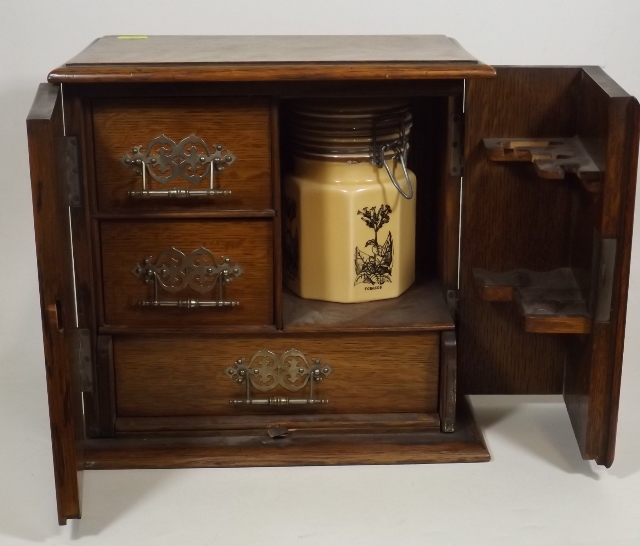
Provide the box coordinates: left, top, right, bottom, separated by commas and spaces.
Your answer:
100, 219, 273, 326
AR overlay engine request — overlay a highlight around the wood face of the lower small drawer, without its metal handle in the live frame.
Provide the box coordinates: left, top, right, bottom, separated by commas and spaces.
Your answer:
100, 219, 274, 326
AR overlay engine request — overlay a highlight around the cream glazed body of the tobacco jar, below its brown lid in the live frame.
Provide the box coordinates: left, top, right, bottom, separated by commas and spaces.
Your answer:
283, 157, 416, 303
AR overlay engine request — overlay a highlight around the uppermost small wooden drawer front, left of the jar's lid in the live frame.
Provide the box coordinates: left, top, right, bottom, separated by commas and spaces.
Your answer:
93, 98, 273, 212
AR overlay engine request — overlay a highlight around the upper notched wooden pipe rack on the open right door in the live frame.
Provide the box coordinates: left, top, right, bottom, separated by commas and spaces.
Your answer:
483, 137, 604, 193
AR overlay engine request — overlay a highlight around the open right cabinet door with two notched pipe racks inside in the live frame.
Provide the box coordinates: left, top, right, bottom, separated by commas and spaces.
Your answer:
458, 67, 639, 466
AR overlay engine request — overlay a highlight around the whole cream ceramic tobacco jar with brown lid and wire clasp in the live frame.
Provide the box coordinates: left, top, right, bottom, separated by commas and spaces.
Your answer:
283, 100, 416, 303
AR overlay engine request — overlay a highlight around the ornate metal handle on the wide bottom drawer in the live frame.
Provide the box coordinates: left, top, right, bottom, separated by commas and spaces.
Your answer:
226, 349, 333, 406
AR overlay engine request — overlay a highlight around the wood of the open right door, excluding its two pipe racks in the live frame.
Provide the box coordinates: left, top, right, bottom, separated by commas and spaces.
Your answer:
460, 63, 638, 466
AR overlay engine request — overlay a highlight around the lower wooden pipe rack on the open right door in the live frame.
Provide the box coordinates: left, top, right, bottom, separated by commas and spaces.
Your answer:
473, 268, 591, 334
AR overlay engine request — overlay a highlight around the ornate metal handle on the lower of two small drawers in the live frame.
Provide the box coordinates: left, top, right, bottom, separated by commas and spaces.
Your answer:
131, 246, 244, 309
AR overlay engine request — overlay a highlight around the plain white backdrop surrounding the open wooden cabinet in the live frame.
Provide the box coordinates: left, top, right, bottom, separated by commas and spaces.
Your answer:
0, 0, 640, 546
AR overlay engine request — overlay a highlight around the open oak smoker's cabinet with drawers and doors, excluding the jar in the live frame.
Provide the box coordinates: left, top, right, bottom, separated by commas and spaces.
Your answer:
27, 36, 639, 524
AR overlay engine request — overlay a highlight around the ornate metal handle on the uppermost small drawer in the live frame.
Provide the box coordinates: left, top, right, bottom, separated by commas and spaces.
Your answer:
120, 135, 236, 198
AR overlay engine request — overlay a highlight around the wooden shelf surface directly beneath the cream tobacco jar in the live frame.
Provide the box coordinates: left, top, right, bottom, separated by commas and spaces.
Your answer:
282, 281, 455, 332
